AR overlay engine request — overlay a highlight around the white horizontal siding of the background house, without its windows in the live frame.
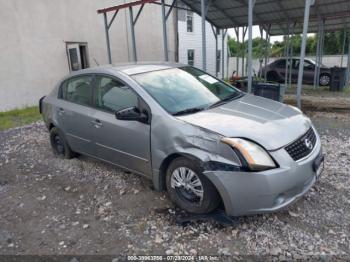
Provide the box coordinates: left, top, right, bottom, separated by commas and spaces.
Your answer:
178, 10, 227, 77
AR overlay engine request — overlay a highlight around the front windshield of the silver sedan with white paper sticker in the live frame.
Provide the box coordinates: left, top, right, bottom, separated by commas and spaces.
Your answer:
132, 66, 242, 115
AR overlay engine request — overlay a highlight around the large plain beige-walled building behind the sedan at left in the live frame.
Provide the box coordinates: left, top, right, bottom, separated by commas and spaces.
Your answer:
0, 0, 177, 111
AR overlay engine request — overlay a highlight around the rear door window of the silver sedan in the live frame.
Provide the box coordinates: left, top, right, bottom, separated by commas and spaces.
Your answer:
61, 76, 93, 105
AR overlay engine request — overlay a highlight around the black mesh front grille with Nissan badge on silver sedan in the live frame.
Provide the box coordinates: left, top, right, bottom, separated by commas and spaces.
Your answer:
285, 128, 316, 161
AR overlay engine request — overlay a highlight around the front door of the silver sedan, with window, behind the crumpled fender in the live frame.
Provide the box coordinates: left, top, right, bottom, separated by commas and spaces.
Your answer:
89, 75, 151, 174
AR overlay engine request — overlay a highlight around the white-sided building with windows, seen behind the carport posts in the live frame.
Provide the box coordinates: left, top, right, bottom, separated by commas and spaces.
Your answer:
178, 5, 227, 78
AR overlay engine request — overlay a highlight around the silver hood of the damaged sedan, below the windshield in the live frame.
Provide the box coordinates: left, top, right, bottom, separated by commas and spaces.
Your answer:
178, 95, 311, 150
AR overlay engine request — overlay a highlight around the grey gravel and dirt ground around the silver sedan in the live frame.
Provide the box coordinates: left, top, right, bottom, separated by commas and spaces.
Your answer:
0, 115, 350, 259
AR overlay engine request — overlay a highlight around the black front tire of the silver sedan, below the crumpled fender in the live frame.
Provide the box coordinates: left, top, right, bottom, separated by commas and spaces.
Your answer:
166, 157, 221, 214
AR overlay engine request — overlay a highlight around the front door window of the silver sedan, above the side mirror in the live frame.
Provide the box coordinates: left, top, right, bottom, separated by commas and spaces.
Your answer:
95, 76, 138, 113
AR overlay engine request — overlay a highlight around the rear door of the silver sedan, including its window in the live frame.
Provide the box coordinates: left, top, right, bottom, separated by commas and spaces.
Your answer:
57, 74, 95, 155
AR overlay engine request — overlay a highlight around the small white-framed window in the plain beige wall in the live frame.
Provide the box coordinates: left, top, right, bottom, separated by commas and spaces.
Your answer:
66, 43, 89, 71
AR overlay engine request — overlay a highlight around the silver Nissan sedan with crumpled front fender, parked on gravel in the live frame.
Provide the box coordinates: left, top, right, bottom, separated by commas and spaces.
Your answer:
40, 64, 323, 216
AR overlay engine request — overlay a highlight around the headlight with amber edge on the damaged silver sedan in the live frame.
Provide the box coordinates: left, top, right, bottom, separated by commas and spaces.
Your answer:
221, 137, 276, 171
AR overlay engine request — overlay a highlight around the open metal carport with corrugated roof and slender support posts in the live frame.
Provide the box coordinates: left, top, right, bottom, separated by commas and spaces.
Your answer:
98, 0, 350, 107
